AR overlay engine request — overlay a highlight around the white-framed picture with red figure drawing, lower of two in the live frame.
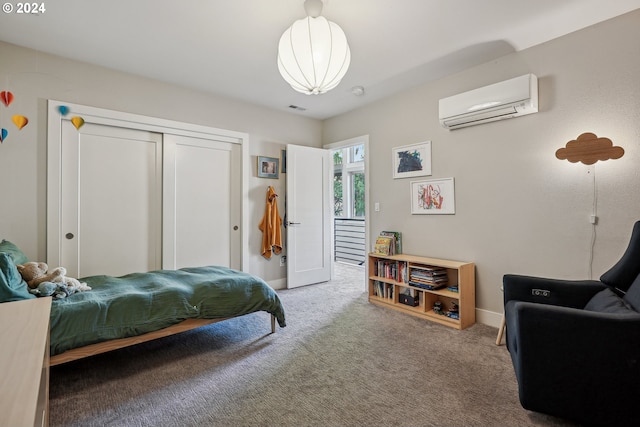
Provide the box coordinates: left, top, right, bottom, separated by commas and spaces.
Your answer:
411, 178, 456, 215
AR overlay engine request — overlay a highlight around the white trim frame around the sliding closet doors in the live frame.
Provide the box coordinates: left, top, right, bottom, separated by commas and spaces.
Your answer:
46, 100, 251, 271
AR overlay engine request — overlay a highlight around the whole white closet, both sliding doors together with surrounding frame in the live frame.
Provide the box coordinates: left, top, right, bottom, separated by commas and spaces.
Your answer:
46, 101, 248, 277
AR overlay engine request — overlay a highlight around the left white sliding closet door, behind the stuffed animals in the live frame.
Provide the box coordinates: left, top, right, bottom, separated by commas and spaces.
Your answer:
60, 121, 162, 277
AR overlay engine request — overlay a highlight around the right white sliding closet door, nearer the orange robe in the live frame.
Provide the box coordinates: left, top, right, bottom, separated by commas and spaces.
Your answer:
163, 134, 242, 269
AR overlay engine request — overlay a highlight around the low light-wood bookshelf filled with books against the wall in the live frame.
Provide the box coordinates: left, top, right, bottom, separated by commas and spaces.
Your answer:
368, 253, 476, 329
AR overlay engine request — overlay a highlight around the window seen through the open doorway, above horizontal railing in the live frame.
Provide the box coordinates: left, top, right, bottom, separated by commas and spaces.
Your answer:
333, 144, 365, 218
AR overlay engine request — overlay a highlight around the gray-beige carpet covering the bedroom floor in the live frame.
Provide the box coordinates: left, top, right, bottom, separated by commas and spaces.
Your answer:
50, 265, 571, 426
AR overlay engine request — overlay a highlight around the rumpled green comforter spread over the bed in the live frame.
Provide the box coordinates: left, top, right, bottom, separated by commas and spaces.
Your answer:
50, 267, 286, 356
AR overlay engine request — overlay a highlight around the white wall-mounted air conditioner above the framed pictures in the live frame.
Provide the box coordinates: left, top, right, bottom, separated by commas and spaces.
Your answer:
439, 74, 538, 130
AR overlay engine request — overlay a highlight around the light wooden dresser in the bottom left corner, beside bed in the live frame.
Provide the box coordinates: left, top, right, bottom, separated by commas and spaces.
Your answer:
0, 298, 51, 427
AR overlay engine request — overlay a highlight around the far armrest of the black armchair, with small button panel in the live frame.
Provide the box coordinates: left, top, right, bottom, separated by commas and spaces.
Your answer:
502, 274, 607, 308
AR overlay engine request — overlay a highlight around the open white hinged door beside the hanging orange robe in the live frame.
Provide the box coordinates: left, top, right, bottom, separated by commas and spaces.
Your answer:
287, 145, 332, 288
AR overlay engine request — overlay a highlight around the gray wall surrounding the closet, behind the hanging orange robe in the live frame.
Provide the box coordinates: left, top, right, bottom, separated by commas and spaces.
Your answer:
0, 42, 322, 285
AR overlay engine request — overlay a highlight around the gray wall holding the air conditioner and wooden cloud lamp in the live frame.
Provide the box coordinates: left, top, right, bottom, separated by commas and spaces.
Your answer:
323, 10, 640, 323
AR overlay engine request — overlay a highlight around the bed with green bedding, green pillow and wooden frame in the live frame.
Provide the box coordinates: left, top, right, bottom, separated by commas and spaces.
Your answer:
0, 239, 286, 365
